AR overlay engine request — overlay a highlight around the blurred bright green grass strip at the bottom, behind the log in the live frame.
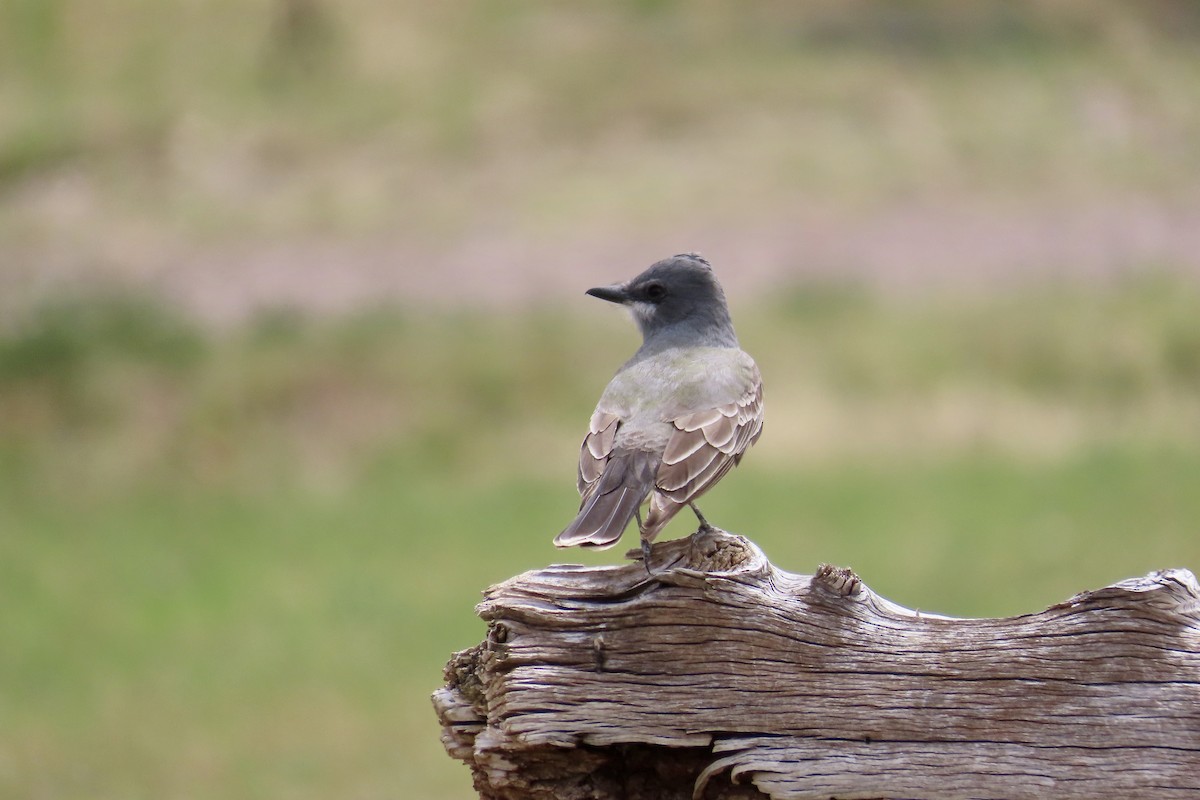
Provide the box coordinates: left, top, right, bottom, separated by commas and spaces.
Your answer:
9, 452, 1200, 798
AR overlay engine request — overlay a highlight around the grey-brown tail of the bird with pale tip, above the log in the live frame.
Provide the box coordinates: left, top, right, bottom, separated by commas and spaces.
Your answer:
554, 450, 660, 549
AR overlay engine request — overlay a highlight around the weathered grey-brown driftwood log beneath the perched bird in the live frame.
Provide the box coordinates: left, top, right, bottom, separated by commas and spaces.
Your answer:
433, 531, 1200, 800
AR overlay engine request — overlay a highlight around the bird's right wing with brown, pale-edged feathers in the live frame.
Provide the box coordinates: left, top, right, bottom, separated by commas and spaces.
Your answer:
647, 369, 762, 510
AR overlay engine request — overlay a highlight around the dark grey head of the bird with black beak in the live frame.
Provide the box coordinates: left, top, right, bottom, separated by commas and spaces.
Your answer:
588, 253, 738, 349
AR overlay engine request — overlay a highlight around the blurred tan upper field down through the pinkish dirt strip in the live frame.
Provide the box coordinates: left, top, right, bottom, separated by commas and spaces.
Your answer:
7, 0, 1200, 320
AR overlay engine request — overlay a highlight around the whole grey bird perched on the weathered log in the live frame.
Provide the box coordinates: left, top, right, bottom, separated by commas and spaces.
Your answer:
554, 253, 762, 569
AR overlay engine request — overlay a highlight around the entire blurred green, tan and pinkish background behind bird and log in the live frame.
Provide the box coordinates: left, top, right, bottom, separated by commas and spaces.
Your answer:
0, 0, 1200, 800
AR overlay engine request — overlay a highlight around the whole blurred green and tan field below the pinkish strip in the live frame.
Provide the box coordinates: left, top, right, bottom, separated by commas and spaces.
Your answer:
0, 279, 1200, 799
